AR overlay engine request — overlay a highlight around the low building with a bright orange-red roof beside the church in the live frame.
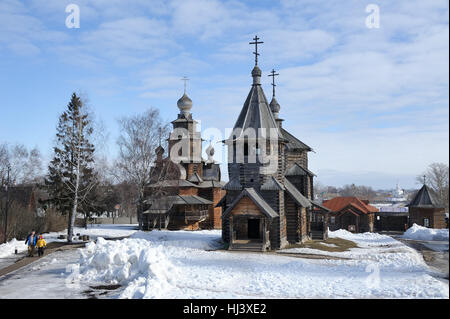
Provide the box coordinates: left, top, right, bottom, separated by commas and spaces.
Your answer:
322, 197, 378, 233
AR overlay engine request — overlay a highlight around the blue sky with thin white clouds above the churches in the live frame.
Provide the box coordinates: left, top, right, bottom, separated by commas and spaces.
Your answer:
0, 0, 449, 188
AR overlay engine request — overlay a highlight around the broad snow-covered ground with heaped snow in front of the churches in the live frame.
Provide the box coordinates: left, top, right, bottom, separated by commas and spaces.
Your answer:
67, 230, 449, 298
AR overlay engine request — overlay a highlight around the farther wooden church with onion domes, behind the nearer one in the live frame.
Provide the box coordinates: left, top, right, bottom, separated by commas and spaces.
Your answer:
143, 92, 225, 230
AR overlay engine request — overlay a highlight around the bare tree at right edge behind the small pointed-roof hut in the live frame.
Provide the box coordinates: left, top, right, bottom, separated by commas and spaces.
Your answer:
416, 163, 449, 212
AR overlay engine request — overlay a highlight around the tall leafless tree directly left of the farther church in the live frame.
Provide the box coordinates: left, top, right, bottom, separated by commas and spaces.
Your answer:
116, 108, 168, 229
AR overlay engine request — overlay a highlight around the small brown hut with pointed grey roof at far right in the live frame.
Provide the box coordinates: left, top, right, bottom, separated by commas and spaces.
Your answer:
408, 184, 447, 228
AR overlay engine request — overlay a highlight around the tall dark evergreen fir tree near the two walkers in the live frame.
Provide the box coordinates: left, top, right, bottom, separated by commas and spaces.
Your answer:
44, 93, 97, 242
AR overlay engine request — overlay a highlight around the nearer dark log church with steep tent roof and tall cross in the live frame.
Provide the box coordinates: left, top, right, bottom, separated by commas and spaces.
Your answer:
219, 37, 329, 251
